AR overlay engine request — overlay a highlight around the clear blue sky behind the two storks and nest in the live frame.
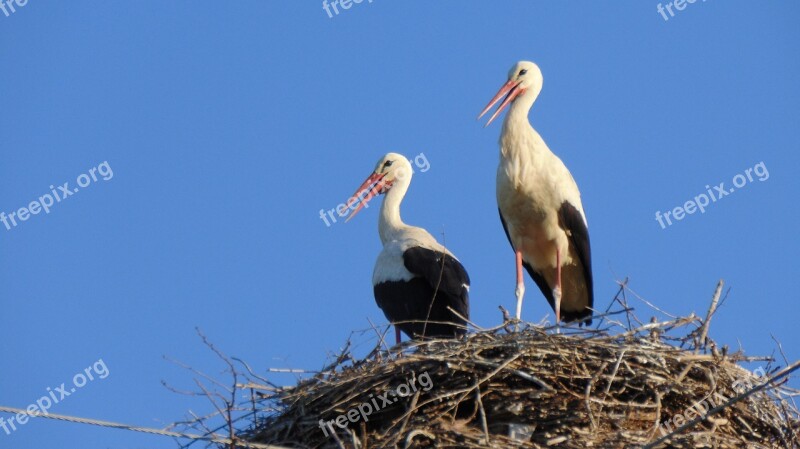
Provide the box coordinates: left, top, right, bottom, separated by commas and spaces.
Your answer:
0, 0, 800, 449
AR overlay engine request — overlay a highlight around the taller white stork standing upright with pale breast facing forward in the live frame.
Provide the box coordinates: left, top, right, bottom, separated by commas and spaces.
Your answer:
478, 61, 594, 324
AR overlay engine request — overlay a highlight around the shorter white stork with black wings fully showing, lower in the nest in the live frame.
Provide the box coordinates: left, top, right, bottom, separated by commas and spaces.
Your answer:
347, 153, 469, 343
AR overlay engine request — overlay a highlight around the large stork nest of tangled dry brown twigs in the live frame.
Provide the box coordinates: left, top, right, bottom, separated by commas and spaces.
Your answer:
246, 316, 800, 449
